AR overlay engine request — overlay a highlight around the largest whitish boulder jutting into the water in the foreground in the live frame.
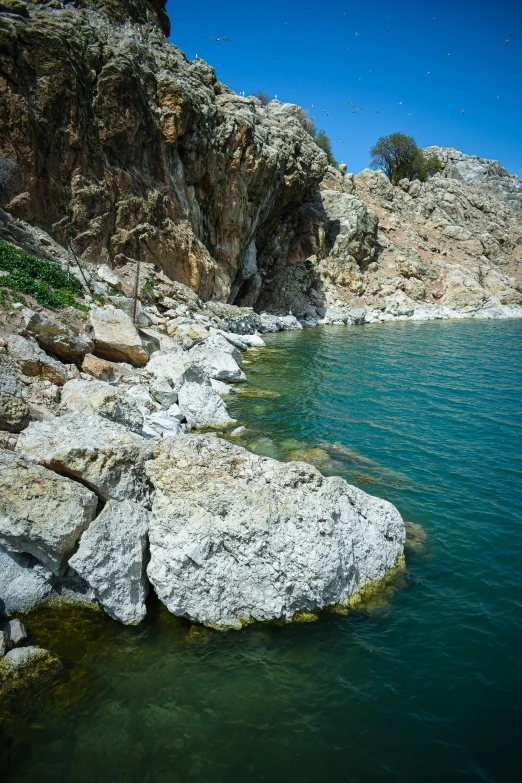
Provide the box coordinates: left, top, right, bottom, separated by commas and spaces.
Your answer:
147, 436, 405, 628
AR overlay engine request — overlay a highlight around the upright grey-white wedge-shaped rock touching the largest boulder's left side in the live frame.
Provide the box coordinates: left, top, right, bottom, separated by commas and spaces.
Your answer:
70, 500, 149, 625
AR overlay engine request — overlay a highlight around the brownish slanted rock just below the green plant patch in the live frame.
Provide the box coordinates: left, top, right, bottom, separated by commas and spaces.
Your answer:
24, 310, 94, 364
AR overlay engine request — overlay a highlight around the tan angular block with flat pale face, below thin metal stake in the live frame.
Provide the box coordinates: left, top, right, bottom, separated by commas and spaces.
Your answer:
90, 307, 149, 367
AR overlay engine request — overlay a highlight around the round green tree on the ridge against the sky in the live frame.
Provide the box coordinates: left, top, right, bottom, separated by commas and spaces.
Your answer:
370, 133, 442, 185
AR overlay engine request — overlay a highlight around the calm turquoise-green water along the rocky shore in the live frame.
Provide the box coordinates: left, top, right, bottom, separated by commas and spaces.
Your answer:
1, 321, 522, 783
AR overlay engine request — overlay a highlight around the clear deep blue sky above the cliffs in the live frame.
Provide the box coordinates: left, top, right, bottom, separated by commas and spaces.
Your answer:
167, 0, 522, 177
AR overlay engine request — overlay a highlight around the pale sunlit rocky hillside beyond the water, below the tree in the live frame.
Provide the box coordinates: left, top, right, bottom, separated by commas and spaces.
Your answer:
317, 147, 522, 313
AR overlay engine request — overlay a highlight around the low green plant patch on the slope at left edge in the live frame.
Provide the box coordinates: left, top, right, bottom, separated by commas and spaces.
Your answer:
0, 239, 88, 312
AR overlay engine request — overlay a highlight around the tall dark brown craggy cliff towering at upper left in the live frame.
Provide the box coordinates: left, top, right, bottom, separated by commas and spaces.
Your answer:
0, 0, 326, 304
